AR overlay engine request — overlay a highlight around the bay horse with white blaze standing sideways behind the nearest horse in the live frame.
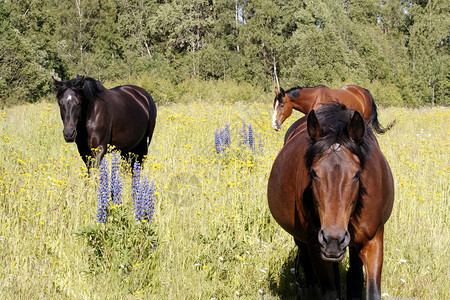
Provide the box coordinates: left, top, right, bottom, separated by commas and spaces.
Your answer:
272, 85, 394, 134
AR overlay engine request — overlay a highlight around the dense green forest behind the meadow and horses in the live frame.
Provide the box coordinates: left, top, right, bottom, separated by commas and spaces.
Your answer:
0, 0, 450, 108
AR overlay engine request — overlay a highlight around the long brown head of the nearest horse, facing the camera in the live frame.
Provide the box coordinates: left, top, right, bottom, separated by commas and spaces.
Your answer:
306, 106, 365, 262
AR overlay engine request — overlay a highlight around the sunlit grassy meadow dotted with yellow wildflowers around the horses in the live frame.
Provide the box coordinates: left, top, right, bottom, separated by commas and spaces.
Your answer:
0, 101, 450, 299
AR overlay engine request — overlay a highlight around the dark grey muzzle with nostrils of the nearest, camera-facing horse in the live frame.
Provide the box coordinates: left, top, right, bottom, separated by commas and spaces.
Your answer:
318, 229, 350, 262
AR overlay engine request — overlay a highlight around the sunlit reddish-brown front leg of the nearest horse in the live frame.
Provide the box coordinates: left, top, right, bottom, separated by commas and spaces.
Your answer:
359, 226, 384, 299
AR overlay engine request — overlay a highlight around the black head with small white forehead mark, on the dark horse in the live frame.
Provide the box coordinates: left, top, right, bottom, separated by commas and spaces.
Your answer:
52, 76, 85, 142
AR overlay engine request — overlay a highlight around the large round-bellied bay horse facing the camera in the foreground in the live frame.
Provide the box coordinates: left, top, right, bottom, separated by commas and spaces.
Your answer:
267, 103, 394, 299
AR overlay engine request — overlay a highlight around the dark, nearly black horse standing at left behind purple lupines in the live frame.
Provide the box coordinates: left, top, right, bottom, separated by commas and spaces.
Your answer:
52, 75, 157, 169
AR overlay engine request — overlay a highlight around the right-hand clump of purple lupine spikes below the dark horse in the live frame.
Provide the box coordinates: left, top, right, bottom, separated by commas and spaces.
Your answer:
132, 162, 156, 222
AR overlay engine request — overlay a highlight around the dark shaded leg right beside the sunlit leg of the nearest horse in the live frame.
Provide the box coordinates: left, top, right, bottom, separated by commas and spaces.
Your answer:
346, 247, 364, 299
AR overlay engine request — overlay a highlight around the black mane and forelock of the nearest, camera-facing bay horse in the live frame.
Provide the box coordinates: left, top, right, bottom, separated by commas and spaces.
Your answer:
305, 102, 372, 170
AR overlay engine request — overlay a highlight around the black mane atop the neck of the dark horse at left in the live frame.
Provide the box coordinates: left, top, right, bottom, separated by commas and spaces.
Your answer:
56, 75, 106, 103
